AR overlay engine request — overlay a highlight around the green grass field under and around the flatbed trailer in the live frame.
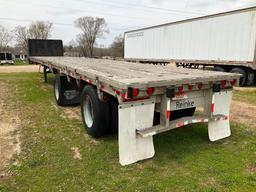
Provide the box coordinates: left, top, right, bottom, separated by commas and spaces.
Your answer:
0, 73, 256, 192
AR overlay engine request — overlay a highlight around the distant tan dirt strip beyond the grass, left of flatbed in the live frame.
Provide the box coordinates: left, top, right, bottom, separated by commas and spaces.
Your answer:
0, 65, 39, 73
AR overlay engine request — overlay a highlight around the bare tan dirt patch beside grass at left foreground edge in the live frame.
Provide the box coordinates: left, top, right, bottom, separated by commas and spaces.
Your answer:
0, 82, 20, 176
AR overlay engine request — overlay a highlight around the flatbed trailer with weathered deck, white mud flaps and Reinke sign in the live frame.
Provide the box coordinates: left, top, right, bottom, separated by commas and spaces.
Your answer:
29, 39, 240, 165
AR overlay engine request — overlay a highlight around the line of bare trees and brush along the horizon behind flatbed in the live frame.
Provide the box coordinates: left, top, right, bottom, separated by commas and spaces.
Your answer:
0, 17, 124, 57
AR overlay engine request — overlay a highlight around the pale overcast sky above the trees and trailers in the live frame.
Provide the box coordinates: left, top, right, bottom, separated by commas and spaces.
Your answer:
0, 0, 256, 47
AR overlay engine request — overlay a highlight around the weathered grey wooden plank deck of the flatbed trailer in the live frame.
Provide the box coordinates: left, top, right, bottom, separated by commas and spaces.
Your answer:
30, 57, 240, 89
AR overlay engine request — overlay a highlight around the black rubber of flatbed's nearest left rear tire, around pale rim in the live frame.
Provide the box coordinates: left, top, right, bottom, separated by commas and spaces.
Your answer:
81, 85, 110, 138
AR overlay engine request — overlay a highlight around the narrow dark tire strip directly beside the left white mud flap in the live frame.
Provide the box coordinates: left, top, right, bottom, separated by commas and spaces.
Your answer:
108, 97, 118, 134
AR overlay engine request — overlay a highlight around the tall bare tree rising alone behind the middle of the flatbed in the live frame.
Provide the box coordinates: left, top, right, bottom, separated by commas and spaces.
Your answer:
75, 17, 108, 57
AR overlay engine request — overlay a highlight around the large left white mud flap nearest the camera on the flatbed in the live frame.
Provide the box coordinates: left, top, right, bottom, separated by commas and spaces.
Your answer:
118, 101, 155, 166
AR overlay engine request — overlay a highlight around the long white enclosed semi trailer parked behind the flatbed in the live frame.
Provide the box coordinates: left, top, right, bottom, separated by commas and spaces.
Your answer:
124, 7, 256, 86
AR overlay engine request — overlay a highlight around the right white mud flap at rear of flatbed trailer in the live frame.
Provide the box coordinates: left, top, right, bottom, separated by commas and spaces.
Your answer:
208, 90, 232, 141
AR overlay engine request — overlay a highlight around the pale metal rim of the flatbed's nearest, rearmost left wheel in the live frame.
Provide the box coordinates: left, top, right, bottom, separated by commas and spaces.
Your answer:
83, 95, 93, 128
